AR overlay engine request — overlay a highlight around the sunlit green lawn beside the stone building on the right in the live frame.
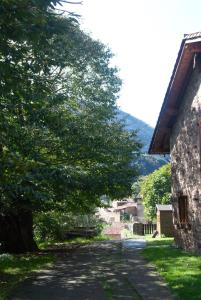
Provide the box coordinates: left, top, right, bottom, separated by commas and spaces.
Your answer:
142, 238, 201, 300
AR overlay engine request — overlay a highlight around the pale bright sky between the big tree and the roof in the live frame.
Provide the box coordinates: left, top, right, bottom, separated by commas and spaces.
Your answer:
63, 0, 201, 126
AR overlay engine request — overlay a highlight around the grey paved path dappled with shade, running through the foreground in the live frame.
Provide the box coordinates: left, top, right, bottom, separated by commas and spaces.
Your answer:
10, 240, 172, 300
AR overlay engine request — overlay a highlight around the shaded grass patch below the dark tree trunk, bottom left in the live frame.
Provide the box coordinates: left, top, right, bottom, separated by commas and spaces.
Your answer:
0, 254, 55, 300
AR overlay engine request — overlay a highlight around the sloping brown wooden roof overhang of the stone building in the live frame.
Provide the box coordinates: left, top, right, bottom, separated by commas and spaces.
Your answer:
148, 32, 201, 154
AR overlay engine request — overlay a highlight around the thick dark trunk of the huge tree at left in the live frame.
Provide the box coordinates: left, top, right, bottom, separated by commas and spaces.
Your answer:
0, 209, 38, 253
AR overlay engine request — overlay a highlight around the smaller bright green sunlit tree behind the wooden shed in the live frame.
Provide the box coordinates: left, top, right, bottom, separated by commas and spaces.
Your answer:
140, 164, 171, 220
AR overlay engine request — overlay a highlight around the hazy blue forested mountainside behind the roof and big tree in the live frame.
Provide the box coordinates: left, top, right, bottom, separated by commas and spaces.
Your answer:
118, 110, 169, 175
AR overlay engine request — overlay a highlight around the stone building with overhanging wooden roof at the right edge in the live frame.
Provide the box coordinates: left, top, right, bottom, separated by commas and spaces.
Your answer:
149, 32, 201, 252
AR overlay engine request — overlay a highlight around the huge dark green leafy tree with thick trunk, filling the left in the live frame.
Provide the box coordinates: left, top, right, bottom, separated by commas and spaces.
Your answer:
0, 0, 140, 252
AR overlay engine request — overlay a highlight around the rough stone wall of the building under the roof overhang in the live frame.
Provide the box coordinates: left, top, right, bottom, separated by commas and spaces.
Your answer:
170, 58, 201, 252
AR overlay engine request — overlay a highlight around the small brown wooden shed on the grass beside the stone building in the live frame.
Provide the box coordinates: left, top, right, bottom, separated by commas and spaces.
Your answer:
156, 204, 174, 236
